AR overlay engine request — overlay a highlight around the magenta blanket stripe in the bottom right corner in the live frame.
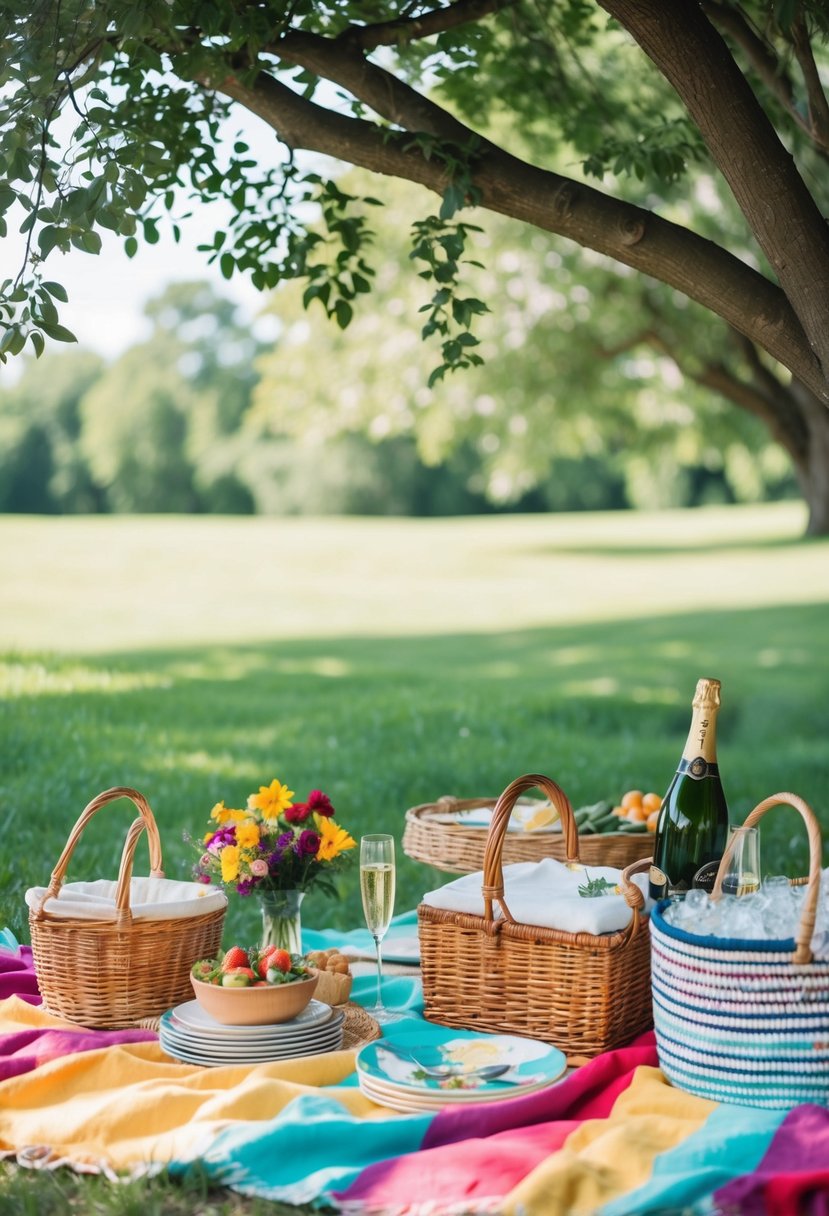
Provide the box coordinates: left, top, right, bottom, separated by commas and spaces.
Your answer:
715, 1103, 829, 1216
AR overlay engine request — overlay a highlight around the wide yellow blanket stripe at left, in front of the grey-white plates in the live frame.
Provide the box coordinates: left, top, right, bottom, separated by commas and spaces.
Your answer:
0, 1001, 382, 1171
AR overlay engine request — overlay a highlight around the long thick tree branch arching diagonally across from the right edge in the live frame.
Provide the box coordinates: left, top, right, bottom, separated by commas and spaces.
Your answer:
215, 73, 829, 401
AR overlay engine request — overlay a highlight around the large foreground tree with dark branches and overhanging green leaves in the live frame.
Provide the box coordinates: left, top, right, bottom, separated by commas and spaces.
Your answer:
0, 0, 829, 533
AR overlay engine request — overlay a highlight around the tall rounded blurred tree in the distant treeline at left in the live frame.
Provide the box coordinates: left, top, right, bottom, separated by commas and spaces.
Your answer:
80, 282, 261, 513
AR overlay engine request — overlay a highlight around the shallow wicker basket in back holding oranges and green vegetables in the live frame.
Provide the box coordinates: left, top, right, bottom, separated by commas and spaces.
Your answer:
402, 794, 654, 874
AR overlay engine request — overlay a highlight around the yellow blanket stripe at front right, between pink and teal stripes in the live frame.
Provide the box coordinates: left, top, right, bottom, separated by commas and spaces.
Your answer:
502, 1066, 717, 1216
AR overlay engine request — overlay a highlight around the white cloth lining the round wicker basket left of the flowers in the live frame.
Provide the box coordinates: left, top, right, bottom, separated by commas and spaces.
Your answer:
26, 878, 227, 921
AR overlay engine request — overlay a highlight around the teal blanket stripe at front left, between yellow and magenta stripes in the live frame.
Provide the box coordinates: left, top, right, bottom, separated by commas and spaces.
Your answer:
169, 1094, 434, 1204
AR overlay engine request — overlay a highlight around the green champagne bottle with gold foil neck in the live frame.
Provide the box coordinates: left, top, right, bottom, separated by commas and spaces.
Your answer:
649, 680, 728, 900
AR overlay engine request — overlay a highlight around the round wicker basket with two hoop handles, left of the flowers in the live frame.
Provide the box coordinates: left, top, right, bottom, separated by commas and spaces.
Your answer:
28, 787, 227, 1030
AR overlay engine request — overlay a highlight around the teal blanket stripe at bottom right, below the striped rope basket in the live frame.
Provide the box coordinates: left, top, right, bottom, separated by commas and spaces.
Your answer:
597, 1105, 786, 1216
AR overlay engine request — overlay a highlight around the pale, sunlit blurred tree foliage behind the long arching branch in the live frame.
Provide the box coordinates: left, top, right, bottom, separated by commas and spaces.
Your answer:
249, 170, 790, 510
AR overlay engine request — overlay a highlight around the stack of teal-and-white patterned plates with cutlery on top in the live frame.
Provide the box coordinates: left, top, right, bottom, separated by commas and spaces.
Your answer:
357, 1035, 566, 1113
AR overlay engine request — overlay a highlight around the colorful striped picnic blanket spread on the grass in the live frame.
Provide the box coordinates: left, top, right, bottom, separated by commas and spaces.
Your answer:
0, 933, 829, 1216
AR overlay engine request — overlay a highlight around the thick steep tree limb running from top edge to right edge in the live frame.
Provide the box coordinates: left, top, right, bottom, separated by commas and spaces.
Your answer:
599, 0, 829, 389
